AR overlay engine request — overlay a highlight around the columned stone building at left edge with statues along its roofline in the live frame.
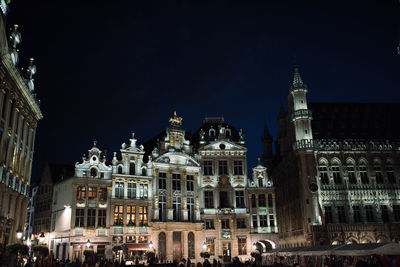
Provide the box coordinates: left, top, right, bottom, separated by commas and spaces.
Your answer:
0, 5, 43, 247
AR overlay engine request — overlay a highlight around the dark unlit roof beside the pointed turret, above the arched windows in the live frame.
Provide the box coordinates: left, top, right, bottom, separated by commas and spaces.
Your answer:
308, 102, 400, 140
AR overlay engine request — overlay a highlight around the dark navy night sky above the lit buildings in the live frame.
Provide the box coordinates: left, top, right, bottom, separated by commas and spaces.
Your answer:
3, 0, 400, 183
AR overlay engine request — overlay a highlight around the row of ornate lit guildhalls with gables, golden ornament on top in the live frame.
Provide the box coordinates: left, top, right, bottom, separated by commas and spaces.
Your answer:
48, 113, 278, 262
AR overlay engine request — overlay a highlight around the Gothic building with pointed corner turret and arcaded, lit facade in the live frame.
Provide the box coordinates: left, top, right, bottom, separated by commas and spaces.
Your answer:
266, 68, 400, 247
